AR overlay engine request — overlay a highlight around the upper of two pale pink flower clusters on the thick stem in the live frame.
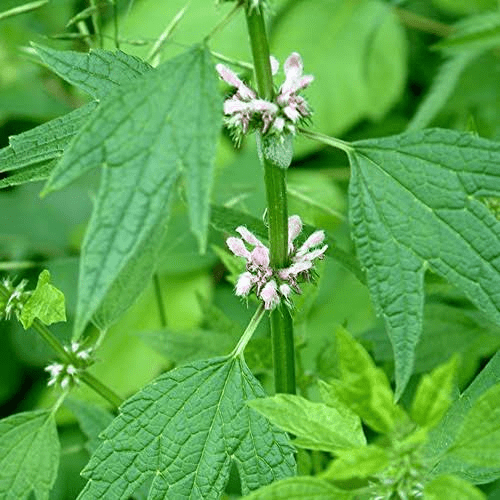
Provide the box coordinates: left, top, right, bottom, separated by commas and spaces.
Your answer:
216, 52, 314, 140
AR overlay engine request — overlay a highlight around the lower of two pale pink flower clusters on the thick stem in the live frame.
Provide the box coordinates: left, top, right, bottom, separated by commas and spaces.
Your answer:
226, 215, 328, 309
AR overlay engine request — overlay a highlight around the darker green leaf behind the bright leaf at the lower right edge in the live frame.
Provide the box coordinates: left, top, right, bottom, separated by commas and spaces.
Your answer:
425, 352, 500, 484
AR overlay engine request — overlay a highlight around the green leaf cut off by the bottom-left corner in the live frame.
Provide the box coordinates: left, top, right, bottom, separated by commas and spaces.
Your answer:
0, 410, 60, 500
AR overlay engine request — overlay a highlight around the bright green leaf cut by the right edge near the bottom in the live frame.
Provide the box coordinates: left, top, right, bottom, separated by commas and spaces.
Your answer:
448, 383, 500, 468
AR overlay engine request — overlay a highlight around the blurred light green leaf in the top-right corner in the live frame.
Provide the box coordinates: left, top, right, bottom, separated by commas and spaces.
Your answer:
434, 12, 500, 53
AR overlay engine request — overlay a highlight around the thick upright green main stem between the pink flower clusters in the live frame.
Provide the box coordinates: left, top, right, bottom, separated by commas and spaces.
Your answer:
246, 3, 296, 394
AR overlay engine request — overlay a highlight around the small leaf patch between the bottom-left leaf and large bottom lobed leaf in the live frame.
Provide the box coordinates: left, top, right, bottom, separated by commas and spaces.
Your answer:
64, 398, 113, 453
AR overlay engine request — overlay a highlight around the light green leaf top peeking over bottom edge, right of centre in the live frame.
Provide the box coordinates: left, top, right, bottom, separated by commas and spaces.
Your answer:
243, 476, 354, 500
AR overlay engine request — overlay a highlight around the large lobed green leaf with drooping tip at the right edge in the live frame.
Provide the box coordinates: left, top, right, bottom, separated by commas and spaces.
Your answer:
348, 129, 500, 396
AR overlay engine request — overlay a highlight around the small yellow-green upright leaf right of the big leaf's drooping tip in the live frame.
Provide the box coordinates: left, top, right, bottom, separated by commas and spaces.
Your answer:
410, 356, 457, 427
